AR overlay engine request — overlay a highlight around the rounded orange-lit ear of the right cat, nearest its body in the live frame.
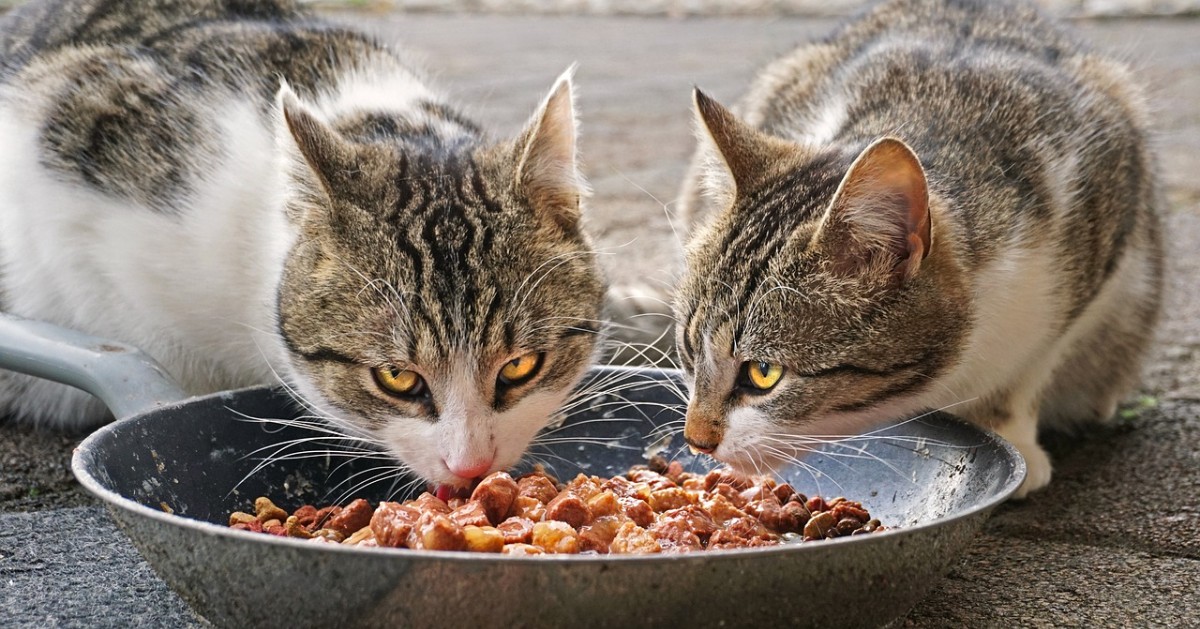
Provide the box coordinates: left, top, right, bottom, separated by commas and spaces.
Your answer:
817, 138, 932, 282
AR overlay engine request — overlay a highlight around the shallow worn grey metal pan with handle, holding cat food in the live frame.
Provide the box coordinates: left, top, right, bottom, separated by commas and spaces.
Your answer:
0, 316, 1025, 628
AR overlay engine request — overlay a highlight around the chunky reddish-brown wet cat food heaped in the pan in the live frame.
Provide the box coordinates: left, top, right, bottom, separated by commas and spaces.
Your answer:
229, 460, 884, 555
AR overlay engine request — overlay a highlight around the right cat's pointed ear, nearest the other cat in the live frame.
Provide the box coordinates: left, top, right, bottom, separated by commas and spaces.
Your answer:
692, 88, 797, 197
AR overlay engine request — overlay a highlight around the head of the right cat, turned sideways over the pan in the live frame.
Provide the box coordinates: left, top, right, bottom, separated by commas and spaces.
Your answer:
676, 90, 970, 471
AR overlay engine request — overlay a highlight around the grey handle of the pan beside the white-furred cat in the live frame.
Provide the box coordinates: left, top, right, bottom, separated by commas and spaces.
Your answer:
0, 312, 187, 419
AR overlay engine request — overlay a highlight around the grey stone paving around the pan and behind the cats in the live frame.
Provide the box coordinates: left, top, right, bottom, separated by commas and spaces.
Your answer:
0, 13, 1200, 628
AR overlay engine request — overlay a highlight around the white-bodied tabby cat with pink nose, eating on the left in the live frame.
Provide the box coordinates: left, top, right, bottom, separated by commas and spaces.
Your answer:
0, 0, 604, 485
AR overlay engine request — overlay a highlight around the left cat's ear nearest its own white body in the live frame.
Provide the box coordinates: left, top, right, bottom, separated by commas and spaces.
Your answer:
276, 82, 359, 211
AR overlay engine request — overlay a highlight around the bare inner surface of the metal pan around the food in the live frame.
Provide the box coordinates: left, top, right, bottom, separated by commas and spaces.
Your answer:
77, 369, 1024, 527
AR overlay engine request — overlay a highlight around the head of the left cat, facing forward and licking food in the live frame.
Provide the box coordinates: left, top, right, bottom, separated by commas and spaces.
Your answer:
278, 73, 604, 485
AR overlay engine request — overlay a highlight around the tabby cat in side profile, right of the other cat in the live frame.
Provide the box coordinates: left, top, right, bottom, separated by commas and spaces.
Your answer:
674, 0, 1163, 496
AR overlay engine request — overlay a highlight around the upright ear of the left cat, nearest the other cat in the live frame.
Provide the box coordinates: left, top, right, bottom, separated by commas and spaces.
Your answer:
514, 66, 588, 232
